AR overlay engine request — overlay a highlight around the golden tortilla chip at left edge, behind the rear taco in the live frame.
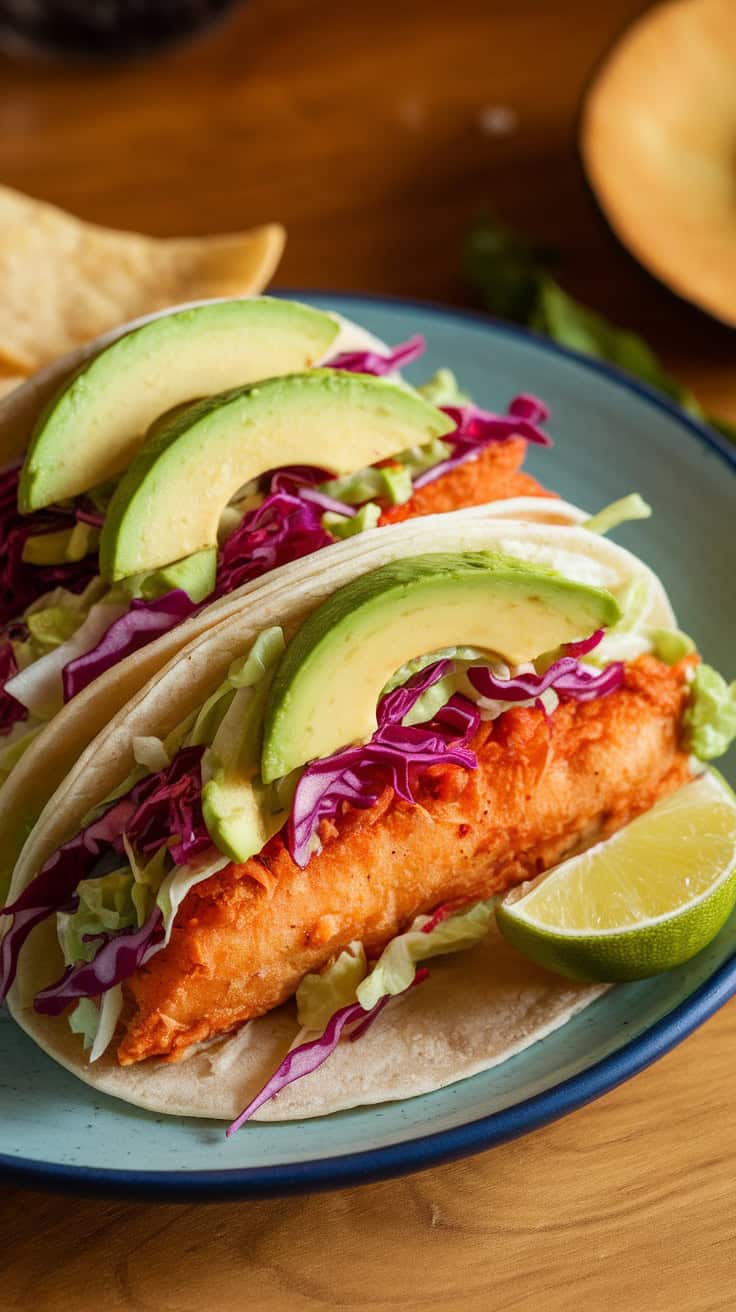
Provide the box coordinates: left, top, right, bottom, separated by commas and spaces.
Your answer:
0, 186, 285, 375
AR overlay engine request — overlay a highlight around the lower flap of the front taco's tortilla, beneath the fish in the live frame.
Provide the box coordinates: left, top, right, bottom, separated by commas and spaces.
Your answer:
13, 928, 606, 1120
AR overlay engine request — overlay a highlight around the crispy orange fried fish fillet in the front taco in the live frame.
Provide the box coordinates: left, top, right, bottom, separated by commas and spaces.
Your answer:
118, 656, 691, 1065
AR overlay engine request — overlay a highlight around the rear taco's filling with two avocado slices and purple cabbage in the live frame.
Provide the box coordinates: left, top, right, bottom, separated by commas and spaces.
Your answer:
0, 298, 550, 777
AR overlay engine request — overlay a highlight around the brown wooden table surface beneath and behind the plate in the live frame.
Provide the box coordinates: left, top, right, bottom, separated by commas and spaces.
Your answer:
0, 0, 736, 1312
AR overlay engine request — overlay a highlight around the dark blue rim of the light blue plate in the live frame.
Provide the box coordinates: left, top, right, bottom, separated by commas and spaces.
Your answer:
0, 295, 736, 1202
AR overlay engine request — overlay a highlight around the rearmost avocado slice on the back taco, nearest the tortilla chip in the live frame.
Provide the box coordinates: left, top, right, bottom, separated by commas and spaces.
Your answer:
18, 297, 340, 513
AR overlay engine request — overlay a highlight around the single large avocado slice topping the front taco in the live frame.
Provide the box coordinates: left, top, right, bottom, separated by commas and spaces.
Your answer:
261, 551, 621, 783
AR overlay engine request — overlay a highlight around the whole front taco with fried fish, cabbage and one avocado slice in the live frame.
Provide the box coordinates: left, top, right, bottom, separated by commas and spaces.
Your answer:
0, 506, 736, 1128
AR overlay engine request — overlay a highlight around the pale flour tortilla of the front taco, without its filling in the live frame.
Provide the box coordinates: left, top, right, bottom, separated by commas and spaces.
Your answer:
9, 506, 674, 1119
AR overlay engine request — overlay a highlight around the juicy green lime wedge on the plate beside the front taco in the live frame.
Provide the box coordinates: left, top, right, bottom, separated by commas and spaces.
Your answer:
496, 770, 736, 981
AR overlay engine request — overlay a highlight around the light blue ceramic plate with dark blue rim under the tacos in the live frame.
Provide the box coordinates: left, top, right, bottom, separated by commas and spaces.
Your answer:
0, 295, 736, 1199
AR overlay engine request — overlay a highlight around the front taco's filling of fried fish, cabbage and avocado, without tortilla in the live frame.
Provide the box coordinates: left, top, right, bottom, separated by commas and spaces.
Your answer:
1, 516, 736, 1124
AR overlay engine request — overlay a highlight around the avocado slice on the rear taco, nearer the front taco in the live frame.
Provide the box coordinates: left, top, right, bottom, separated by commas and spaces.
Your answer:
100, 369, 454, 580
